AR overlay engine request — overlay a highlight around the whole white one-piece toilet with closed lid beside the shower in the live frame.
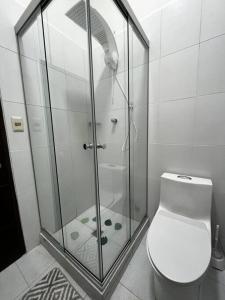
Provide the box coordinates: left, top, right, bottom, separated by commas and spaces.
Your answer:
146, 173, 212, 300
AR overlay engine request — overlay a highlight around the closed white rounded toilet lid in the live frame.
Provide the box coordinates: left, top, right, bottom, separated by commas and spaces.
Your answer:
146, 210, 211, 284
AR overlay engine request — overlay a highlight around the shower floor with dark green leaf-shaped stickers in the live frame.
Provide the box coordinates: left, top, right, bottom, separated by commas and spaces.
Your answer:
56, 205, 138, 276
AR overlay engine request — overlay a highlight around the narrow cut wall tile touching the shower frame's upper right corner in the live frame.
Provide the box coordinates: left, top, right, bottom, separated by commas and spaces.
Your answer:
141, 11, 161, 61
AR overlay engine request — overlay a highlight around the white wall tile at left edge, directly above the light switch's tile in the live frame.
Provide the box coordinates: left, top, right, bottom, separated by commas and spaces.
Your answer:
0, 47, 24, 102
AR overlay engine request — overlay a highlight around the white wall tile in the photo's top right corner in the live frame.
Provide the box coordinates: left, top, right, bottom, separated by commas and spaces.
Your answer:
201, 0, 225, 41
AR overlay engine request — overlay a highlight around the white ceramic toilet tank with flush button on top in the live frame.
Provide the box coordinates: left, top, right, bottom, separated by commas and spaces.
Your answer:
160, 173, 212, 219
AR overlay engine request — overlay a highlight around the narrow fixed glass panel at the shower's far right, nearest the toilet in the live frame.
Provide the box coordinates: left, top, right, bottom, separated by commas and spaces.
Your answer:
129, 24, 149, 234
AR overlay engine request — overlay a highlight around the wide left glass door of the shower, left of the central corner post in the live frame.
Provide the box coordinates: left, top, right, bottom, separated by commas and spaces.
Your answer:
42, 0, 99, 277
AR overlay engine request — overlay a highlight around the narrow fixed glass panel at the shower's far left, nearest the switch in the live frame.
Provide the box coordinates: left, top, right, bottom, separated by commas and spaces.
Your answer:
19, 14, 63, 245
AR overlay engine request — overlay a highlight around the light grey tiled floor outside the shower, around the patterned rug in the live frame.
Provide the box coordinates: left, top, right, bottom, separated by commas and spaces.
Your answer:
0, 233, 225, 300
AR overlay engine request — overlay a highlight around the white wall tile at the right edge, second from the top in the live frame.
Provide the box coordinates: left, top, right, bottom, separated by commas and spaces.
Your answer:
198, 35, 225, 95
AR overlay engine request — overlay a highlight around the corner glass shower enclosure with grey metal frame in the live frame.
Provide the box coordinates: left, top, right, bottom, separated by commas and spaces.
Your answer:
16, 0, 149, 296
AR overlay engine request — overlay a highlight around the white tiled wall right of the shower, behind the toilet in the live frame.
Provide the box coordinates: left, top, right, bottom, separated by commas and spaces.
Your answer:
126, 0, 225, 247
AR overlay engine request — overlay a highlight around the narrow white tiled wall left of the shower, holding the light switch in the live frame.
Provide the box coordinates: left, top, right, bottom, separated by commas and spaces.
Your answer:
0, 0, 40, 250
